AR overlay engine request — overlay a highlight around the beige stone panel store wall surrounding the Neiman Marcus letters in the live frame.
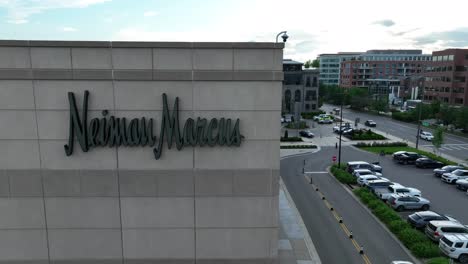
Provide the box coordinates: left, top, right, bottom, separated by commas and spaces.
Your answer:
0, 41, 283, 264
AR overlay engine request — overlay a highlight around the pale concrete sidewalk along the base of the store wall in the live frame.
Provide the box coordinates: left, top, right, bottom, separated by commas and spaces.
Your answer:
278, 150, 321, 264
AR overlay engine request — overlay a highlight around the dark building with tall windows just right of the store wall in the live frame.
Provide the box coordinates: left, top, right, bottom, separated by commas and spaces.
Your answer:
282, 59, 319, 114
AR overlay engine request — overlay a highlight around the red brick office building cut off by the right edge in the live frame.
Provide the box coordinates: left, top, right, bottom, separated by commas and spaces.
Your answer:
423, 49, 468, 106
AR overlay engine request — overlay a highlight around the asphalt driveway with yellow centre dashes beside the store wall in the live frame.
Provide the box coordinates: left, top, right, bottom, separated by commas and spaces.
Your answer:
281, 147, 411, 264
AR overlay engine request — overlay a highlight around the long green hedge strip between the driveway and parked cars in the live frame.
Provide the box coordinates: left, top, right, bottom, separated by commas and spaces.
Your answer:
353, 188, 441, 258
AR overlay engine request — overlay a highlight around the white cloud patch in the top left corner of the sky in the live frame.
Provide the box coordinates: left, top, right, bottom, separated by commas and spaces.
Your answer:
0, 0, 111, 24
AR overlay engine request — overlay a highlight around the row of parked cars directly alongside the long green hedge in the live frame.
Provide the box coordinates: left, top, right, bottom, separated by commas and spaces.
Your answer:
347, 161, 468, 263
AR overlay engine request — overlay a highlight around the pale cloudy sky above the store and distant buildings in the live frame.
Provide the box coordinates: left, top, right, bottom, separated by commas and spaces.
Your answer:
0, 0, 468, 61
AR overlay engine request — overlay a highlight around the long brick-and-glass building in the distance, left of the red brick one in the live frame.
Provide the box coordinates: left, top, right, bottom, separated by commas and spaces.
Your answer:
340, 50, 431, 88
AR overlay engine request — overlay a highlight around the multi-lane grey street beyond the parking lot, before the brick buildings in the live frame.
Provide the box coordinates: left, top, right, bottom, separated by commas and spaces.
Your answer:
322, 105, 468, 160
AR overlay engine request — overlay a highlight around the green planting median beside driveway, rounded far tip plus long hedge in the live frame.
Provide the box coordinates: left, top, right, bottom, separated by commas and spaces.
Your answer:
330, 164, 449, 264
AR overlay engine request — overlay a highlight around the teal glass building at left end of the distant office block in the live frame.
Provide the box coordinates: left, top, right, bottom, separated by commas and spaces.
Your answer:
318, 52, 362, 85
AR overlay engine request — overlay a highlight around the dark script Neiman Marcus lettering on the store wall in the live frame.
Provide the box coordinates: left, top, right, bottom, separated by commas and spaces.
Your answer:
64, 91, 244, 159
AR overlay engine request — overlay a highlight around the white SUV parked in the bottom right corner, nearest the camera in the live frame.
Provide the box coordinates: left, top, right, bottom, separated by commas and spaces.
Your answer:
439, 234, 468, 264
